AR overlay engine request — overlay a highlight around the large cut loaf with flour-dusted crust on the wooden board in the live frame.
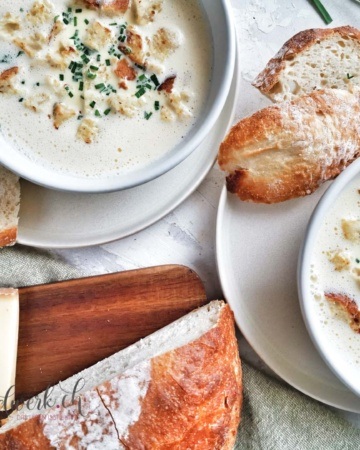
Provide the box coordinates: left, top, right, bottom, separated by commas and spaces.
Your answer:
0, 301, 242, 450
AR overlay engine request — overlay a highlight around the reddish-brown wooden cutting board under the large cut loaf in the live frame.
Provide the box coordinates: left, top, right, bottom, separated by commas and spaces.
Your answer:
16, 266, 207, 399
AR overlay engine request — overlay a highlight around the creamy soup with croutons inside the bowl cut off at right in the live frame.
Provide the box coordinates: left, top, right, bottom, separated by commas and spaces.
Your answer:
310, 179, 360, 372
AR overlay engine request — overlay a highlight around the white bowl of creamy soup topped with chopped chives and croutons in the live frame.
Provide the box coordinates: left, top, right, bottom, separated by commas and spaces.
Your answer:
0, 0, 236, 192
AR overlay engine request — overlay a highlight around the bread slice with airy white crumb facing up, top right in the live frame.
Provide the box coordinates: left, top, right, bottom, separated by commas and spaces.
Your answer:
253, 26, 360, 102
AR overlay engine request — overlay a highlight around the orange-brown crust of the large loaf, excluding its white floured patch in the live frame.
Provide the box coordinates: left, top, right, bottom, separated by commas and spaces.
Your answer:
0, 305, 242, 450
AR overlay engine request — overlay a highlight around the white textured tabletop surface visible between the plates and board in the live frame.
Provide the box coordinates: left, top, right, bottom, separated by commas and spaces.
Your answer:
48, 0, 360, 426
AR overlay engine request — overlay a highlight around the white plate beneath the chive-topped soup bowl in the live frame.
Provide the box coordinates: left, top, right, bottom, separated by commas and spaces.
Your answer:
18, 41, 239, 248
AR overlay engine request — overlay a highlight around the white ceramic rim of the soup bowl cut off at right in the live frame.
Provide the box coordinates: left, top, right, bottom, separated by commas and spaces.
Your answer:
297, 159, 360, 396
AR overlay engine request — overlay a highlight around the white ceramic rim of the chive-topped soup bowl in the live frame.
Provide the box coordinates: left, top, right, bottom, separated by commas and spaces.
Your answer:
0, 0, 236, 193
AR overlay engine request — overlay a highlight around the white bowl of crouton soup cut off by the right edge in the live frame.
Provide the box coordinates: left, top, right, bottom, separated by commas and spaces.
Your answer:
298, 160, 360, 395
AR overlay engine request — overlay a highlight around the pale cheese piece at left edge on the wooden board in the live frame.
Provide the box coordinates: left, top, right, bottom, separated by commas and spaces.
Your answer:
0, 289, 19, 411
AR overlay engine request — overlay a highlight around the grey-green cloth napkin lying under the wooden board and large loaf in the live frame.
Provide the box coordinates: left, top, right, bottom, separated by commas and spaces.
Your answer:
0, 246, 360, 450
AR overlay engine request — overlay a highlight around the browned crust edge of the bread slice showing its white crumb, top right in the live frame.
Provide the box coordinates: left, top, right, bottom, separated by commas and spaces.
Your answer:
252, 26, 360, 95
